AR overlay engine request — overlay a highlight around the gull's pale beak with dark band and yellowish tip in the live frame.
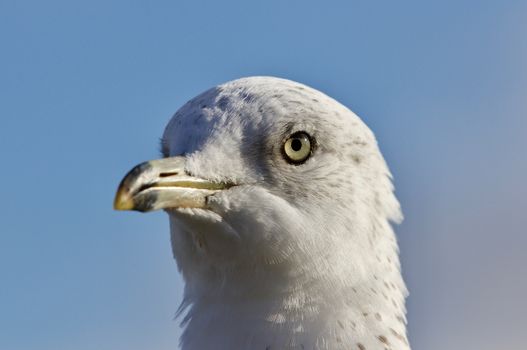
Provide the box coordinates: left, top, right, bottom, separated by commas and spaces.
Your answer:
113, 157, 233, 212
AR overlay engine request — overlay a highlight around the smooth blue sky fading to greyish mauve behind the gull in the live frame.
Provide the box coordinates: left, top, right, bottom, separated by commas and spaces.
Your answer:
0, 0, 527, 350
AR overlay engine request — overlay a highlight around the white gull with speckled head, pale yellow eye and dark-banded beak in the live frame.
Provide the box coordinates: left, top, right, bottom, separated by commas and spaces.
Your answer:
114, 77, 410, 350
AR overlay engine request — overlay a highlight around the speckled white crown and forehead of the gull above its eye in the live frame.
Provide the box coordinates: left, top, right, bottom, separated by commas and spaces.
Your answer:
163, 77, 366, 154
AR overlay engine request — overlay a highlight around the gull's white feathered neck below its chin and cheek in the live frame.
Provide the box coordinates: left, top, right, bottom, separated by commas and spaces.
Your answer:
172, 200, 409, 350
